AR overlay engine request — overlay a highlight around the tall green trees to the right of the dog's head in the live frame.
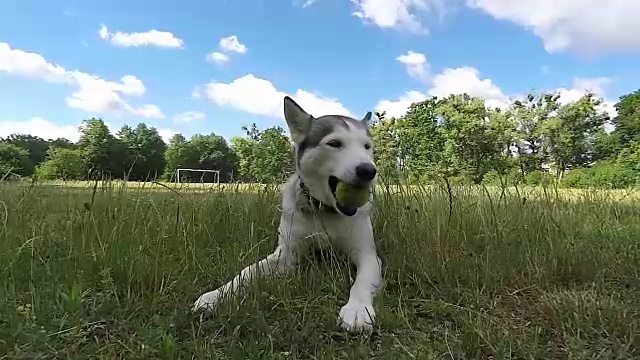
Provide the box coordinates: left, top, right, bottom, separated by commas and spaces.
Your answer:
373, 90, 640, 188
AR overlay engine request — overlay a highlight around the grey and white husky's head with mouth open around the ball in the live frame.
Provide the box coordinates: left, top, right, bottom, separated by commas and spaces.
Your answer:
284, 96, 377, 215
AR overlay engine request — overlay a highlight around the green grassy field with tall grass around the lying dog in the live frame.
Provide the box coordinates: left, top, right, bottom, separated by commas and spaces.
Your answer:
0, 183, 640, 359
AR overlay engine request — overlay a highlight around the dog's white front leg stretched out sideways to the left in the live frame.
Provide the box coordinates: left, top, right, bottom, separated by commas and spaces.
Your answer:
193, 243, 296, 311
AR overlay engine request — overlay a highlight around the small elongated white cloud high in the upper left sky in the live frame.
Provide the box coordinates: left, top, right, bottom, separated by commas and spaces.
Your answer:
98, 25, 184, 48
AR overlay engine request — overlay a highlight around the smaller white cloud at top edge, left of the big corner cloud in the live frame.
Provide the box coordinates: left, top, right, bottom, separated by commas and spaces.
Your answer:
351, 0, 445, 33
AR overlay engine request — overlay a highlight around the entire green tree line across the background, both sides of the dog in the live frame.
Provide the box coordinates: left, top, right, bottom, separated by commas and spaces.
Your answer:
0, 90, 640, 188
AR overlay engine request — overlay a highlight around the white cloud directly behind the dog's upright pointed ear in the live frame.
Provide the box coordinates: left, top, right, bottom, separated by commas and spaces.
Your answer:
204, 74, 353, 118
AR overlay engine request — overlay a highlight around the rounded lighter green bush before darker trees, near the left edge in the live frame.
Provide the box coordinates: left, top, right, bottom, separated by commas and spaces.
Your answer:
36, 147, 87, 180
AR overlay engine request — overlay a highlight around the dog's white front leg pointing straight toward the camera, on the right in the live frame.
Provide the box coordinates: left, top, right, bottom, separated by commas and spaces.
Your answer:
339, 226, 382, 331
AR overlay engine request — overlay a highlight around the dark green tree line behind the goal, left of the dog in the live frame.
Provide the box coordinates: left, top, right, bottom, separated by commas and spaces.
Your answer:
0, 118, 293, 183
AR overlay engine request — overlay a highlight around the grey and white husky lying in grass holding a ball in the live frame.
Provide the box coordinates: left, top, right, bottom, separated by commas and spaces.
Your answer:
193, 96, 382, 331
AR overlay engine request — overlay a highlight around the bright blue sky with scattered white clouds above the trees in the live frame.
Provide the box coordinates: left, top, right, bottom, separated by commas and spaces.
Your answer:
0, 0, 640, 140
